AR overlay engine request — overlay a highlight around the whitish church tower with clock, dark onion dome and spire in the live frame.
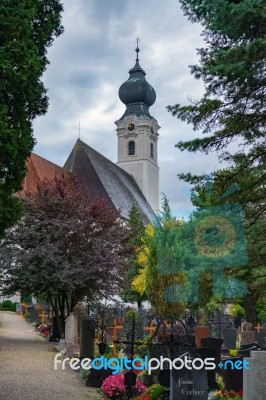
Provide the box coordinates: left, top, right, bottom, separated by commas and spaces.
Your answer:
115, 41, 160, 211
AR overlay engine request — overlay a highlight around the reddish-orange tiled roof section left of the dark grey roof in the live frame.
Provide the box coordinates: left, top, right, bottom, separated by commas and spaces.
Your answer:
17, 153, 67, 197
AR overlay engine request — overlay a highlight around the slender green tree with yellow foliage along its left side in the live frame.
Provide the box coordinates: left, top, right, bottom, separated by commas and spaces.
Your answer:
132, 200, 189, 318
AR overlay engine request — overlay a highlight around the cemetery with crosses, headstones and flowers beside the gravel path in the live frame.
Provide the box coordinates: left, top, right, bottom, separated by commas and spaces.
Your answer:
13, 302, 266, 400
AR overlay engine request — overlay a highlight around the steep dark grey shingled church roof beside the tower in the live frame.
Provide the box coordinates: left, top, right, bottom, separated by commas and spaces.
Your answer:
64, 139, 154, 223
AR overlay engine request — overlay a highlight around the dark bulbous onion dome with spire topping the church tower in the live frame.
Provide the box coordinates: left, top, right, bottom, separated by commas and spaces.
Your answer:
118, 47, 156, 119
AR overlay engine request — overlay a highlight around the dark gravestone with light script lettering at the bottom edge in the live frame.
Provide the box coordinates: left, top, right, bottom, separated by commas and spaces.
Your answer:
170, 368, 208, 400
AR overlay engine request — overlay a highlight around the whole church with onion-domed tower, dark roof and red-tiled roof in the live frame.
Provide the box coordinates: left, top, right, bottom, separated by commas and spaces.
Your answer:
19, 46, 160, 224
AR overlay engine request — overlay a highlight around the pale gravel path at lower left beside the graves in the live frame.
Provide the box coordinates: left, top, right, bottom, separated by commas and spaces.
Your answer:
0, 312, 102, 400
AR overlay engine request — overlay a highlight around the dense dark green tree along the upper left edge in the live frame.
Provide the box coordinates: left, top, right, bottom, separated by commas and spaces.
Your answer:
0, 0, 63, 235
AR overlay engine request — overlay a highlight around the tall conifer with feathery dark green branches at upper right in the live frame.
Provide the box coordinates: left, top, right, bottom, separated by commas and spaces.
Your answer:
168, 0, 266, 219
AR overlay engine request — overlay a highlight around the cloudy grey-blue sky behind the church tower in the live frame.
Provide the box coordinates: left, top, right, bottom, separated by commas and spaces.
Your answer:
34, 0, 219, 215
